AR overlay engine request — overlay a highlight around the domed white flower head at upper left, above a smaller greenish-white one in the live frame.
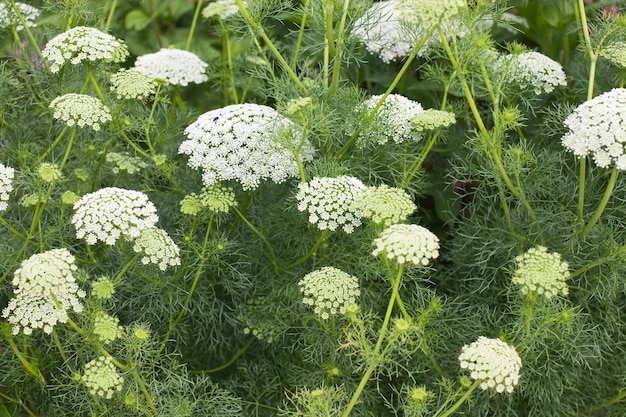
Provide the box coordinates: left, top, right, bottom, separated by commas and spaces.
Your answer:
41, 26, 128, 73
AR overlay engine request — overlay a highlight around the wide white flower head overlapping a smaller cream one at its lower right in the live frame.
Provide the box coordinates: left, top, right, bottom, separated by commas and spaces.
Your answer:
72, 187, 158, 245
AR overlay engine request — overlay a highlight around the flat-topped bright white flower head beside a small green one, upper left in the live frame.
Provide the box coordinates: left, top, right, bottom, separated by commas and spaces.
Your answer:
132, 48, 209, 87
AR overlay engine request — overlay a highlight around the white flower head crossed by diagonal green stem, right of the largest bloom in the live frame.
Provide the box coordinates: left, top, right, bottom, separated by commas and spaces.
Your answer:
357, 94, 424, 146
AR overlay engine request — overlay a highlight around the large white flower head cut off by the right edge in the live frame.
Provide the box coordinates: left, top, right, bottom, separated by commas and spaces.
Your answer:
561, 88, 626, 171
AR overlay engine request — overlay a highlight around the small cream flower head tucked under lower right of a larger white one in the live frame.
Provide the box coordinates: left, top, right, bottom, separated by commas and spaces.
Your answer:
133, 227, 180, 271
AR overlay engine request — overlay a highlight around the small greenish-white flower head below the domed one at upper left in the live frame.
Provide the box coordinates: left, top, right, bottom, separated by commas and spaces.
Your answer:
50, 93, 111, 131
